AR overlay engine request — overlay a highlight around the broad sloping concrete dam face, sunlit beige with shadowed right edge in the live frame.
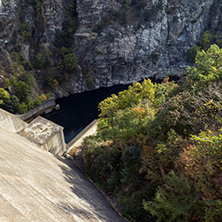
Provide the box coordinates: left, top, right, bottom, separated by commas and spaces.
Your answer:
0, 129, 124, 222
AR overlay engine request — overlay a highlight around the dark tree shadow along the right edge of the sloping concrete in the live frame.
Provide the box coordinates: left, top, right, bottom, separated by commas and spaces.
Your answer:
56, 156, 126, 222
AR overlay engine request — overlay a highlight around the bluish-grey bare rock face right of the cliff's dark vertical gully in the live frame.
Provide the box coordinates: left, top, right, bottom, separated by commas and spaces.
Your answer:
75, 0, 221, 86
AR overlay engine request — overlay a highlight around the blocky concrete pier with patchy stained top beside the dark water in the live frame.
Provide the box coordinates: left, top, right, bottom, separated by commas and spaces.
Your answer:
20, 116, 66, 155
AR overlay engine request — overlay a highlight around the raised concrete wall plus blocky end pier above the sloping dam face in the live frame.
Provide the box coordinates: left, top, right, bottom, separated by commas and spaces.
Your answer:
0, 109, 66, 155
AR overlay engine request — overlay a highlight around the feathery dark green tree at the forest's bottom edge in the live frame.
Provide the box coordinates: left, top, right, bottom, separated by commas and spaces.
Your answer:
144, 171, 196, 222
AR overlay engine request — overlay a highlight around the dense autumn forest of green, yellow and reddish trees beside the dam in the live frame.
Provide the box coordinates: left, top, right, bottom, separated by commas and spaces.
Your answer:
82, 45, 222, 222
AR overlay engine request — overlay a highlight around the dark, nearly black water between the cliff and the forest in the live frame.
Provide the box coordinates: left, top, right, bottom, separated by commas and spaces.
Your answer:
43, 85, 128, 143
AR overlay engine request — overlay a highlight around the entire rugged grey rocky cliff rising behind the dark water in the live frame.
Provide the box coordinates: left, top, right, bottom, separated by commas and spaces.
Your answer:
0, 0, 222, 97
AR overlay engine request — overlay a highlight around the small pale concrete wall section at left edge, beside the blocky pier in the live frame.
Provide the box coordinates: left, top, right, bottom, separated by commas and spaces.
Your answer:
0, 109, 28, 132
